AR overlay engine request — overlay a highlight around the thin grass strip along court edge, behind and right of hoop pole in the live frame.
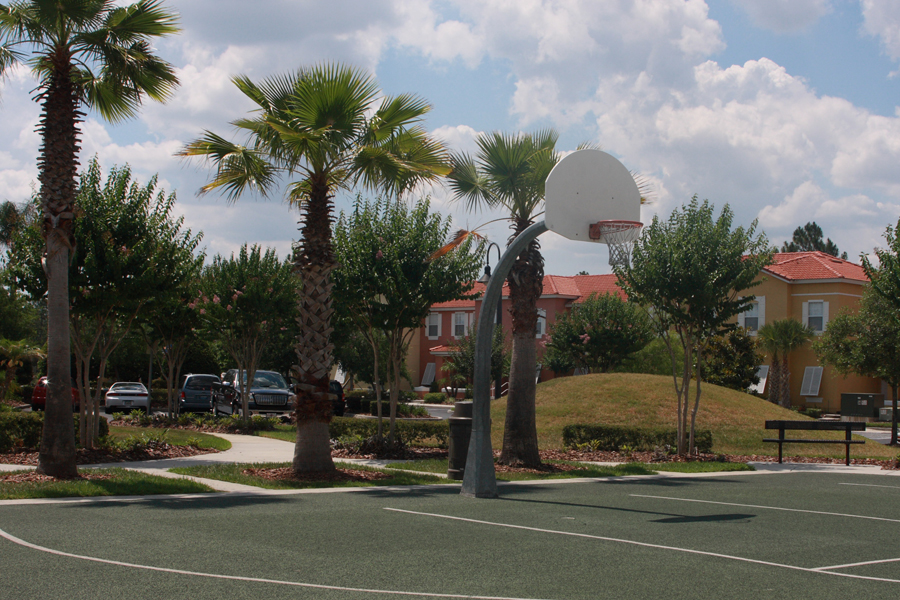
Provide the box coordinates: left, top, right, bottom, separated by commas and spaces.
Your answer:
387, 458, 754, 481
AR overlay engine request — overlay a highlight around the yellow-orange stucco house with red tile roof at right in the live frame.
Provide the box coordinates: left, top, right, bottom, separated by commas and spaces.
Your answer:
738, 252, 890, 413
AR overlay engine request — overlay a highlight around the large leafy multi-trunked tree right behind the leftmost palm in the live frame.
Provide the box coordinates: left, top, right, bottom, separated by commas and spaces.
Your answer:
10, 159, 200, 447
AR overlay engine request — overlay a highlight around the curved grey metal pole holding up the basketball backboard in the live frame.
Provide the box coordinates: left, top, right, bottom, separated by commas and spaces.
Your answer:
460, 221, 547, 498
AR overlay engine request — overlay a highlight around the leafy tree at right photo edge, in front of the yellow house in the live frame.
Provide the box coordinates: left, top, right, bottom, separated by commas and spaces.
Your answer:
813, 288, 900, 446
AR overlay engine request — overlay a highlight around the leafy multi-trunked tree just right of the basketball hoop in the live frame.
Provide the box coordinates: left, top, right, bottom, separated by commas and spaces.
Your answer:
615, 196, 772, 454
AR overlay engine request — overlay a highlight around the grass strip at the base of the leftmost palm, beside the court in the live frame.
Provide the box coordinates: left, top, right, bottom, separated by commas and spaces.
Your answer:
0, 468, 214, 500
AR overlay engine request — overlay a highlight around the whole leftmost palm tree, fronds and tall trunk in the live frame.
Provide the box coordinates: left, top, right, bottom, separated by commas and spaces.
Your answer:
0, 0, 178, 478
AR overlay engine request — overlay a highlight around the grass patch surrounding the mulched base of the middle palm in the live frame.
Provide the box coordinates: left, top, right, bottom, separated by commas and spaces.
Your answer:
169, 462, 448, 490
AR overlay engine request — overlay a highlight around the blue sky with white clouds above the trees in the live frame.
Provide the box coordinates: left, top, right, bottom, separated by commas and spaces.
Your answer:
0, 0, 900, 275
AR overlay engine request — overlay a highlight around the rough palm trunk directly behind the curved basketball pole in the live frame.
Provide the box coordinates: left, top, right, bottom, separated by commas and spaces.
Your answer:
500, 221, 544, 467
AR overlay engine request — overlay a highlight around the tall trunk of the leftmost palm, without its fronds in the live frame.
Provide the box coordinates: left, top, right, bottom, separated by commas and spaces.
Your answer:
37, 51, 80, 479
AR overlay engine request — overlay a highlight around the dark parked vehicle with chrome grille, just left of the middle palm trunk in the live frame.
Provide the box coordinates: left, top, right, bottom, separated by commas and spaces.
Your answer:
211, 369, 293, 415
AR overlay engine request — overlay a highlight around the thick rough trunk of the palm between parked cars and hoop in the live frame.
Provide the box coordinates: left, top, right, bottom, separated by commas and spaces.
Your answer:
292, 176, 335, 473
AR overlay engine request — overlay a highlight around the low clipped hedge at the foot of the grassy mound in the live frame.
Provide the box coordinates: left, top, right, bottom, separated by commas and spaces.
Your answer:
563, 424, 712, 453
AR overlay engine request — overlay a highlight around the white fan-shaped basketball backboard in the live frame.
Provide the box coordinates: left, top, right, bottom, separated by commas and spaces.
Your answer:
544, 150, 641, 242
